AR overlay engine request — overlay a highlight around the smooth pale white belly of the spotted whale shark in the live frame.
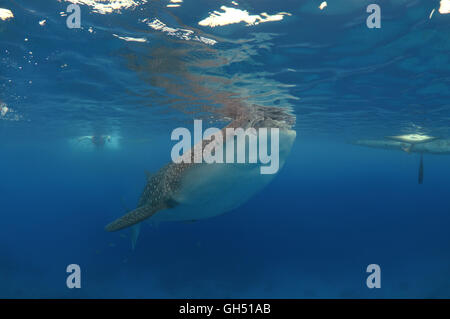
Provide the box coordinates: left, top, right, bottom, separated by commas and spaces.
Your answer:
151, 130, 295, 221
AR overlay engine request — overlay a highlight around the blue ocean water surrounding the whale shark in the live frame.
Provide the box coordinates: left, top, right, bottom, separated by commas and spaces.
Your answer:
0, 0, 450, 298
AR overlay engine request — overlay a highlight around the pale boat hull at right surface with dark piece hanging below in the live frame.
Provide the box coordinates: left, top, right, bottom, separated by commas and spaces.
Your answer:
353, 134, 450, 184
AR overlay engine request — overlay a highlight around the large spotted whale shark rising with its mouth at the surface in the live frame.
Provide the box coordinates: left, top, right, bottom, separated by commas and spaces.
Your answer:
105, 105, 296, 236
